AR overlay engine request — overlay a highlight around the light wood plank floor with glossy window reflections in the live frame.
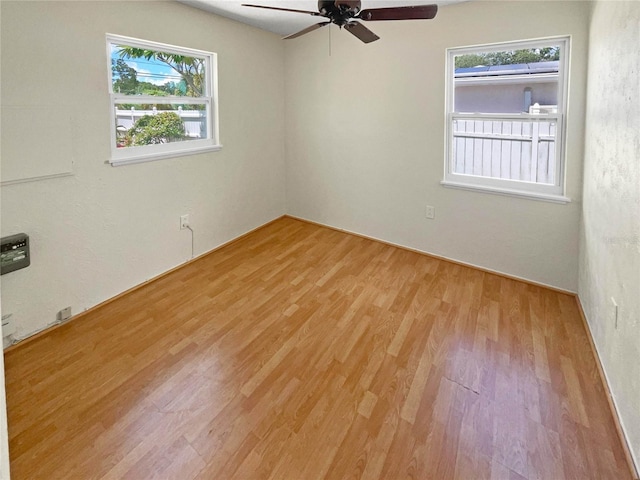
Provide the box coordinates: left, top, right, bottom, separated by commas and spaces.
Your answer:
5, 218, 631, 480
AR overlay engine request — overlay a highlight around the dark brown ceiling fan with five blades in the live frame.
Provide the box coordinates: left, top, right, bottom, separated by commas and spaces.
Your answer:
243, 0, 438, 43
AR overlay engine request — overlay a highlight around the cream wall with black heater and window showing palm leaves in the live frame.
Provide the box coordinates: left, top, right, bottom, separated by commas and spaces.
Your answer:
0, 1, 285, 337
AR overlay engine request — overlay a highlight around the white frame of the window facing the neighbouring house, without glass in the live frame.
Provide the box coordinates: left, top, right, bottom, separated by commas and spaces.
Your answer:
440, 35, 571, 203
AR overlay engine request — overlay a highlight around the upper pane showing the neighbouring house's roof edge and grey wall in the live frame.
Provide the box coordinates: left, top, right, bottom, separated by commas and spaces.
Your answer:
454, 46, 560, 113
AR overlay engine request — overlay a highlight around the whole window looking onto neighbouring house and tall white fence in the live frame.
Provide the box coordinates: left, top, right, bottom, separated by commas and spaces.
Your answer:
442, 37, 569, 202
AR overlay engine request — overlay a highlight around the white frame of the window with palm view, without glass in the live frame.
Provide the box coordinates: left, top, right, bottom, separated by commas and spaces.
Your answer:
106, 33, 222, 166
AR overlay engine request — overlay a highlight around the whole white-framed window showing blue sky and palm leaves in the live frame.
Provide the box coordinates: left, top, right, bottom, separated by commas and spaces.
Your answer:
107, 35, 221, 165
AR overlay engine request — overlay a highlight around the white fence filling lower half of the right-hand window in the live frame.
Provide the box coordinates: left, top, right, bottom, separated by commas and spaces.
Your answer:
451, 114, 559, 185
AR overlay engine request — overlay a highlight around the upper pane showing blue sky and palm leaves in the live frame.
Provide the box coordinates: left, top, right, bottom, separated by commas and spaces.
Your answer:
110, 43, 207, 97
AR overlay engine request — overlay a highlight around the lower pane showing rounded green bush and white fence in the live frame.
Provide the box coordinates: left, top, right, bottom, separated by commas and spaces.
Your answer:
115, 102, 209, 148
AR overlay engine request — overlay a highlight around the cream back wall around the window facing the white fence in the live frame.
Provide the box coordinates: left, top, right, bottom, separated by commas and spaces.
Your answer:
285, 1, 588, 291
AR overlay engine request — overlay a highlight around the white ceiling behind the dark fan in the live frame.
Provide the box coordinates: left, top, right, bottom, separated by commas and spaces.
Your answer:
178, 0, 467, 36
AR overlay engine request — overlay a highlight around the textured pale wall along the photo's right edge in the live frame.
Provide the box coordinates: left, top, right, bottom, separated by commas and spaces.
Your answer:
579, 1, 640, 472
